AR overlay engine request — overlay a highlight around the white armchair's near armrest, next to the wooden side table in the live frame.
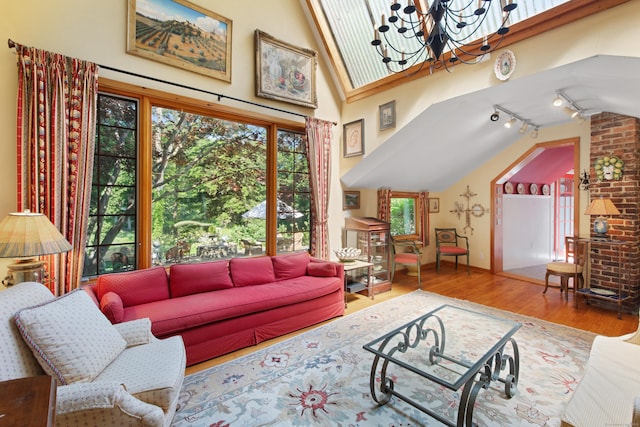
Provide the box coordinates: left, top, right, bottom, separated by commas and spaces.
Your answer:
56, 382, 165, 426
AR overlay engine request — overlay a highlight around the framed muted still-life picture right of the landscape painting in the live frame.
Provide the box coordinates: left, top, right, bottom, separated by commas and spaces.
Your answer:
255, 30, 318, 108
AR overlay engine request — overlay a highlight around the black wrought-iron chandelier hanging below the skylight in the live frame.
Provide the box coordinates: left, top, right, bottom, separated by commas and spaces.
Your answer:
371, 0, 518, 73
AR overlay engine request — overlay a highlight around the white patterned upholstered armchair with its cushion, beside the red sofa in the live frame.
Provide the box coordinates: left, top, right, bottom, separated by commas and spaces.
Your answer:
0, 282, 186, 426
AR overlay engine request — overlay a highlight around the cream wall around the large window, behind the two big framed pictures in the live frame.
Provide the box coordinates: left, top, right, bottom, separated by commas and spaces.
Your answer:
0, 0, 343, 274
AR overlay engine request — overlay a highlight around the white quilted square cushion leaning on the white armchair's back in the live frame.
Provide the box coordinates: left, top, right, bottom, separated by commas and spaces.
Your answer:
15, 289, 126, 385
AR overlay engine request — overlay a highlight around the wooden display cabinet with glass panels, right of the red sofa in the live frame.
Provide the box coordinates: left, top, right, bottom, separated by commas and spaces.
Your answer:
344, 217, 391, 296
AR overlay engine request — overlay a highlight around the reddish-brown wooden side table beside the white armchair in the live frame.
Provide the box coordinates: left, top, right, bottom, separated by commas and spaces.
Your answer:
0, 375, 56, 427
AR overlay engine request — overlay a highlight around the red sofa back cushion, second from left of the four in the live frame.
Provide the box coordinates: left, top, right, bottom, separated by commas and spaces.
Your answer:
169, 260, 233, 298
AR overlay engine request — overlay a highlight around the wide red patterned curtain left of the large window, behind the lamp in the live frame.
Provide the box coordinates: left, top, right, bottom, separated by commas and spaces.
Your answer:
16, 45, 98, 295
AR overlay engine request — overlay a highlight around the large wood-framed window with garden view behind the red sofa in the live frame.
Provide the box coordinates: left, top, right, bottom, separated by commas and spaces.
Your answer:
84, 88, 311, 277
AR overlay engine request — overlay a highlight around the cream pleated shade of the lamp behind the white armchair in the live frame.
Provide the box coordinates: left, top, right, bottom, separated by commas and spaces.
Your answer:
0, 211, 72, 258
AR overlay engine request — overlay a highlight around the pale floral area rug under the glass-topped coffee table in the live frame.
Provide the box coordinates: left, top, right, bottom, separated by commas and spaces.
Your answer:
173, 291, 594, 427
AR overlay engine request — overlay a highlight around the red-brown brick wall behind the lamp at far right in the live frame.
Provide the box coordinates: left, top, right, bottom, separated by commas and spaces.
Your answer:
589, 113, 640, 311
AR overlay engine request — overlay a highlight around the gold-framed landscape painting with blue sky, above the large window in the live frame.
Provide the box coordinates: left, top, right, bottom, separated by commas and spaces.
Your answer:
127, 0, 232, 82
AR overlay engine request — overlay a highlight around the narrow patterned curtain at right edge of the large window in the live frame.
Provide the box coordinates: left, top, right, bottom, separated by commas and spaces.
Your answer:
306, 117, 333, 259
